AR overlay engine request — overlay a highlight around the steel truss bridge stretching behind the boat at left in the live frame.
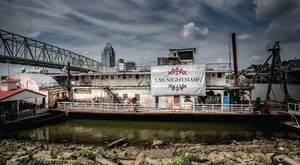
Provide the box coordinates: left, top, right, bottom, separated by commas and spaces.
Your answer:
0, 30, 107, 72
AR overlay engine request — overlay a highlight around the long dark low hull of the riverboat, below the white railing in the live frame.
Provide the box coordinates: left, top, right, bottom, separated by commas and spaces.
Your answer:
51, 108, 289, 124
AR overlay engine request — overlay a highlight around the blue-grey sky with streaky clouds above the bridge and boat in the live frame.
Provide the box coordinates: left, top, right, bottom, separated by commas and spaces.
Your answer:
0, 0, 300, 74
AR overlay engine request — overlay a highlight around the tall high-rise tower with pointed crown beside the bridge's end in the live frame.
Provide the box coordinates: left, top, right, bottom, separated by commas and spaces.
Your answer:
101, 42, 116, 67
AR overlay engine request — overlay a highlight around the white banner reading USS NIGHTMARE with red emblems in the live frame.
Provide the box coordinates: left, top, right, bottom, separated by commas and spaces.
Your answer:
151, 65, 206, 96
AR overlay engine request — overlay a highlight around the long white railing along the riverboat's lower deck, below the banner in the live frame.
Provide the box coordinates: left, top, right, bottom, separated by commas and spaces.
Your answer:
57, 102, 253, 112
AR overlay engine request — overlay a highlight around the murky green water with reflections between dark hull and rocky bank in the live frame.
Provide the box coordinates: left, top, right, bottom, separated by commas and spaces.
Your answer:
10, 120, 296, 143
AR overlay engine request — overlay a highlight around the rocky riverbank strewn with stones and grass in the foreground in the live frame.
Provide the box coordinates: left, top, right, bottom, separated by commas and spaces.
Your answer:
0, 138, 300, 165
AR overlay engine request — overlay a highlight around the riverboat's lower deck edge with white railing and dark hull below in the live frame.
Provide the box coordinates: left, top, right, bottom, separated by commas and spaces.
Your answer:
50, 102, 287, 122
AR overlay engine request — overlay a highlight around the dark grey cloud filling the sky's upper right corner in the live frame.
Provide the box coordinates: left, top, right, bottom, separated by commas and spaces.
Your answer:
254, 0, 300, 43
